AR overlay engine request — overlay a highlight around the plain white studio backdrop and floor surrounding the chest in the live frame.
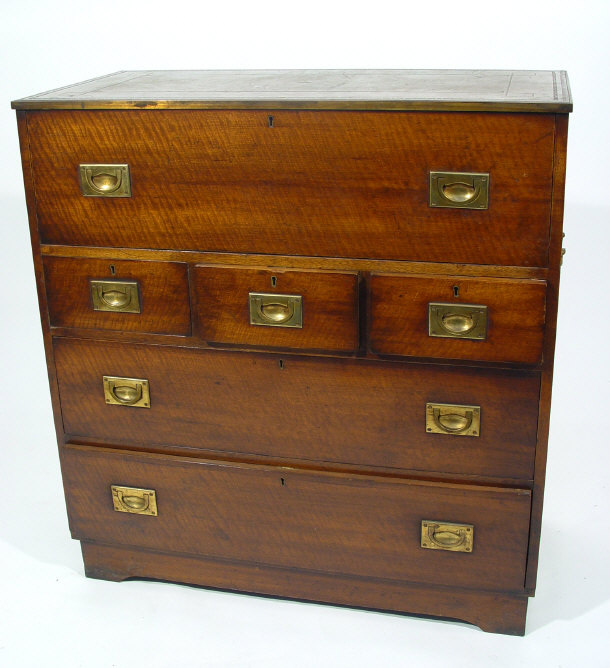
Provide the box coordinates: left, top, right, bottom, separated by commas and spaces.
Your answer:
0, 0, 610, 668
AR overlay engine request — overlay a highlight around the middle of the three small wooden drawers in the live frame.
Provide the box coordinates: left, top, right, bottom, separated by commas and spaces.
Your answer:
192, 265, 359, 352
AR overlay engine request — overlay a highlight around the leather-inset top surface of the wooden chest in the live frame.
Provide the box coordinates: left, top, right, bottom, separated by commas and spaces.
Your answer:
12, 69, 572, 113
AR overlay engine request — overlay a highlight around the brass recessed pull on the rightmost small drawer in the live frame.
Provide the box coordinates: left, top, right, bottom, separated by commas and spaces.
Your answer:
428, 302, 487, 341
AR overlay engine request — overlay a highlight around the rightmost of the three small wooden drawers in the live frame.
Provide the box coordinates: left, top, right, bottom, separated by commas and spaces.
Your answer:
370, 274, 546, 364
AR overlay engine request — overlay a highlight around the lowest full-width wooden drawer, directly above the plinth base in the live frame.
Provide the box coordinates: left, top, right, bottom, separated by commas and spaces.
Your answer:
62, 445, 530, 591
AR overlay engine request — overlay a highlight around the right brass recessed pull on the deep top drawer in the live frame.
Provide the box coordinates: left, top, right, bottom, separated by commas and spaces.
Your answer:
430, 172, 489, 209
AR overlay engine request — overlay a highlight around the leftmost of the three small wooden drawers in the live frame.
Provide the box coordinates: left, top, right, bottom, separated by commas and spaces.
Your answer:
43, 256, 191, 336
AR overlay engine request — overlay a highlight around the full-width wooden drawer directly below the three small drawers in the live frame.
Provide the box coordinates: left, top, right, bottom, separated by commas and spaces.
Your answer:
55, 339, 540, 480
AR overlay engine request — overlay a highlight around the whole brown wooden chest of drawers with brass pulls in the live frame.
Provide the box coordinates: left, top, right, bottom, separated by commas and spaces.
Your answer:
13, 70, 571, 634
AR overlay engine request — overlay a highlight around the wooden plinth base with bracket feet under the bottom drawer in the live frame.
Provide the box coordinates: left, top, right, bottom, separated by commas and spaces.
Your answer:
81, 542, 528, 635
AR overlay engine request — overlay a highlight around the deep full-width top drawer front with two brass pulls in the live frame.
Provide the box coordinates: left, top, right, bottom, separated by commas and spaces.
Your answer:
28, 110, 555, 266
